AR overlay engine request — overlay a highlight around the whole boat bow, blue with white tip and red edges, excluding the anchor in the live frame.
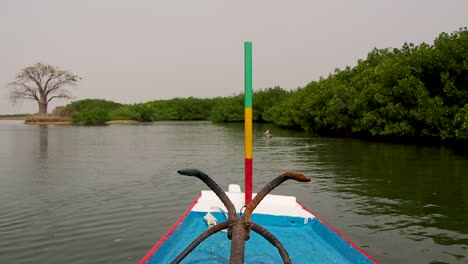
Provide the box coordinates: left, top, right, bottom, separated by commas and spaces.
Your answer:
139, 191, 377, 264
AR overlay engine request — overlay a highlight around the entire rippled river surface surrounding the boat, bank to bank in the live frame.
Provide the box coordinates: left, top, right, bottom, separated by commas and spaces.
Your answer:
0, 121, 468, 264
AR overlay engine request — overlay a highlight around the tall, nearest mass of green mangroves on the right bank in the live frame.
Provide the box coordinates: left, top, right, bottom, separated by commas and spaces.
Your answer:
267, 28, 468, 140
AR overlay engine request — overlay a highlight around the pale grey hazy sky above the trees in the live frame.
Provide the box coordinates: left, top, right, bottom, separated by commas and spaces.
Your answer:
0, 0, 468, 114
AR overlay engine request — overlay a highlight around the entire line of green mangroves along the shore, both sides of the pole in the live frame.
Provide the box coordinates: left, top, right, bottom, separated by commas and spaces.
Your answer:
56, 28, 468, 140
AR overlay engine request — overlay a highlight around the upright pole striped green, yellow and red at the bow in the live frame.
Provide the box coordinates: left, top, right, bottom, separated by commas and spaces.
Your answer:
244, 42, 253, 205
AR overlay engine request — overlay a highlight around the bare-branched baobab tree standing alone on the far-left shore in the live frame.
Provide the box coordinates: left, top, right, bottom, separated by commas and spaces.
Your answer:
8, 63, 81, 116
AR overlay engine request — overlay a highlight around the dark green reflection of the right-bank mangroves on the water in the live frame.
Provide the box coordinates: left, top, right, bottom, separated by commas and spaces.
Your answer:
296, 140, 468, 263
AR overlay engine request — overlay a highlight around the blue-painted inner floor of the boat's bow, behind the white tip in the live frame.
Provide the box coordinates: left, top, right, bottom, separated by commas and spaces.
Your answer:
147, 212, 374, 264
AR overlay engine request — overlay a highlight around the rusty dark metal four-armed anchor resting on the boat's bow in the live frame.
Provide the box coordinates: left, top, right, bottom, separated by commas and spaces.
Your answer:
171, 169, 310, 264
